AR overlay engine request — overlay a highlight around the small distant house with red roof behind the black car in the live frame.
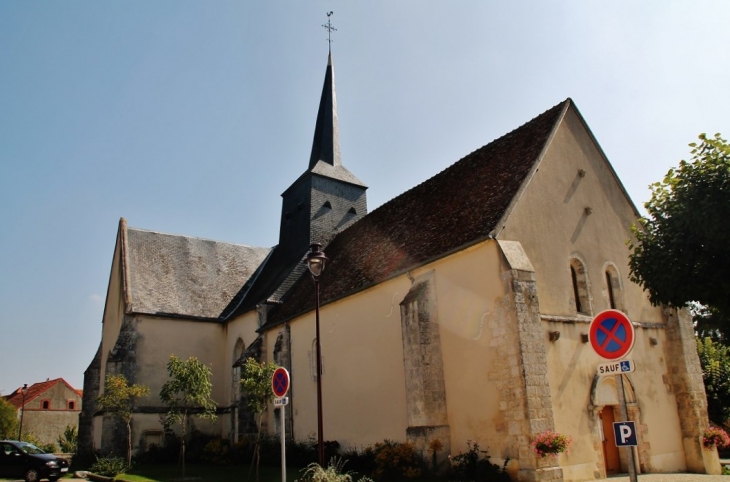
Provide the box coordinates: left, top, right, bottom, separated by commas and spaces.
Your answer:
3, 378, 83, 444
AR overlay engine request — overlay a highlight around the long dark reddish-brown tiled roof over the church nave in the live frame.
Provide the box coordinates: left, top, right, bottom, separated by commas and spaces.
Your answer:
262, 99, 572, 329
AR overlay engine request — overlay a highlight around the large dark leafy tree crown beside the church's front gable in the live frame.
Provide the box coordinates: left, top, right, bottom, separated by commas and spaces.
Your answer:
629, 134, 730, 319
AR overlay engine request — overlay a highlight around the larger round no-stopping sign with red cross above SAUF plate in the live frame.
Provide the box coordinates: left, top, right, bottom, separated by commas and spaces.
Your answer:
588, 310, 636, 360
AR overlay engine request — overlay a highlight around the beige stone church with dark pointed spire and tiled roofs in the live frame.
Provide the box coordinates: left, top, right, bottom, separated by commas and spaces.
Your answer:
80, 53, 720, 481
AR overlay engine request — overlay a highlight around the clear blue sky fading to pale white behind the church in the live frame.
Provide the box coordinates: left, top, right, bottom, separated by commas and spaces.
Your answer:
0, 0, 730, 394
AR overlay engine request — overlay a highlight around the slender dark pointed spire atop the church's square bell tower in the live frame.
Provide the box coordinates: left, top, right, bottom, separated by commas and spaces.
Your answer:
309, 52, 342, 170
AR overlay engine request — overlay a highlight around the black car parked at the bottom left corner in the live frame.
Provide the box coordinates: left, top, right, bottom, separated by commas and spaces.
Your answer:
0, 440, 68, 482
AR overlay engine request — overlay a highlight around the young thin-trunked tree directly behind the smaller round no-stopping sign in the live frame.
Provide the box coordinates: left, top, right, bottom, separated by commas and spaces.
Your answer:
241, 358, 278, 480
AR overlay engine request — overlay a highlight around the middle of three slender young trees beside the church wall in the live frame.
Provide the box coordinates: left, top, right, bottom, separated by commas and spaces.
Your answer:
160, 355, 218, 478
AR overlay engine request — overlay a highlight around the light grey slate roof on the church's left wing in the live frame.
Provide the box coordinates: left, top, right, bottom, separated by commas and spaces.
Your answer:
124, 228, 270, 319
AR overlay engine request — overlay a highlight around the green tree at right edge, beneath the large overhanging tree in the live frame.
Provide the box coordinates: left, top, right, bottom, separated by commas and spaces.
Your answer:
697, 338, 730, 424
